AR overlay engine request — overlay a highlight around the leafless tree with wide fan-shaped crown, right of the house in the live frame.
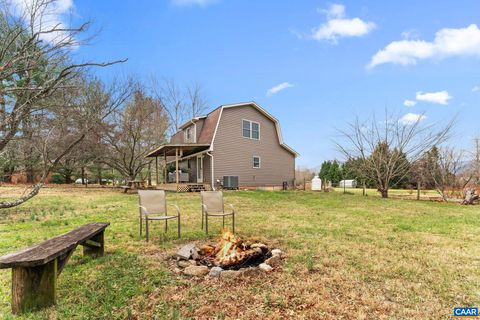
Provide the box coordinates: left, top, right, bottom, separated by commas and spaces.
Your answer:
336, 111, 453, 198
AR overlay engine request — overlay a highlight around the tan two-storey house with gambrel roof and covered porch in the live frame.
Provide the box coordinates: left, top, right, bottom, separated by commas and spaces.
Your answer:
148, 102, 298, 189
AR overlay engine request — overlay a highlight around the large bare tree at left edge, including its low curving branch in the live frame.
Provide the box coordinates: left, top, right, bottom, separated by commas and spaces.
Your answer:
0, 0, 127, 208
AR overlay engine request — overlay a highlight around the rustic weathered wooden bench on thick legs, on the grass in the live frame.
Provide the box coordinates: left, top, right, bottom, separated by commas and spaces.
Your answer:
0, 222, 110, 314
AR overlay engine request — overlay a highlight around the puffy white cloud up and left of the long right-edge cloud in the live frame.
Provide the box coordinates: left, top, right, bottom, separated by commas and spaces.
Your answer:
311, 4, 375, 43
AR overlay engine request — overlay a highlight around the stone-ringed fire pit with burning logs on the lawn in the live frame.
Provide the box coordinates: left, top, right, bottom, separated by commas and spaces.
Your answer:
174, 231, 284, 279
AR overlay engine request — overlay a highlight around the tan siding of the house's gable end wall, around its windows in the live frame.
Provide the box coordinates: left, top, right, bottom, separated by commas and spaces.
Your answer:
213, 106, 295, 186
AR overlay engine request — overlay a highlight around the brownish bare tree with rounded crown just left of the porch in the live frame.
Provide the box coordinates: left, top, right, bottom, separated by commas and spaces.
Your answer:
101, 83, 169, 181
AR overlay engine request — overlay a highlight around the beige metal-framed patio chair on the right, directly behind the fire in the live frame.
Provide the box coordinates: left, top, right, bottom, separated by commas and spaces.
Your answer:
200, 191, 235, 235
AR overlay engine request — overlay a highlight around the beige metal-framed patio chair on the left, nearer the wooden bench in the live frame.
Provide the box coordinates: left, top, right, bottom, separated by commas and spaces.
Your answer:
138, 190, 180, 241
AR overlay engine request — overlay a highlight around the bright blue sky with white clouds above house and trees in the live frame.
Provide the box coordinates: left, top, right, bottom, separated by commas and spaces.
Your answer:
64, 0, 480, 167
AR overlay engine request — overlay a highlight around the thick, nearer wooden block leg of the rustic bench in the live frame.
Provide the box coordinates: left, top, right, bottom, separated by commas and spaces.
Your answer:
12, 259, 57, 314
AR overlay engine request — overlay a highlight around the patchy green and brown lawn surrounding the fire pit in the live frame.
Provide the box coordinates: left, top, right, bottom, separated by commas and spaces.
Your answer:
0, 188, 480, 319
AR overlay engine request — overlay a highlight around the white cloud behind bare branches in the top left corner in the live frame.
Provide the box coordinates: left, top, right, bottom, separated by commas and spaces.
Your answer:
11, 0, 74, 43
